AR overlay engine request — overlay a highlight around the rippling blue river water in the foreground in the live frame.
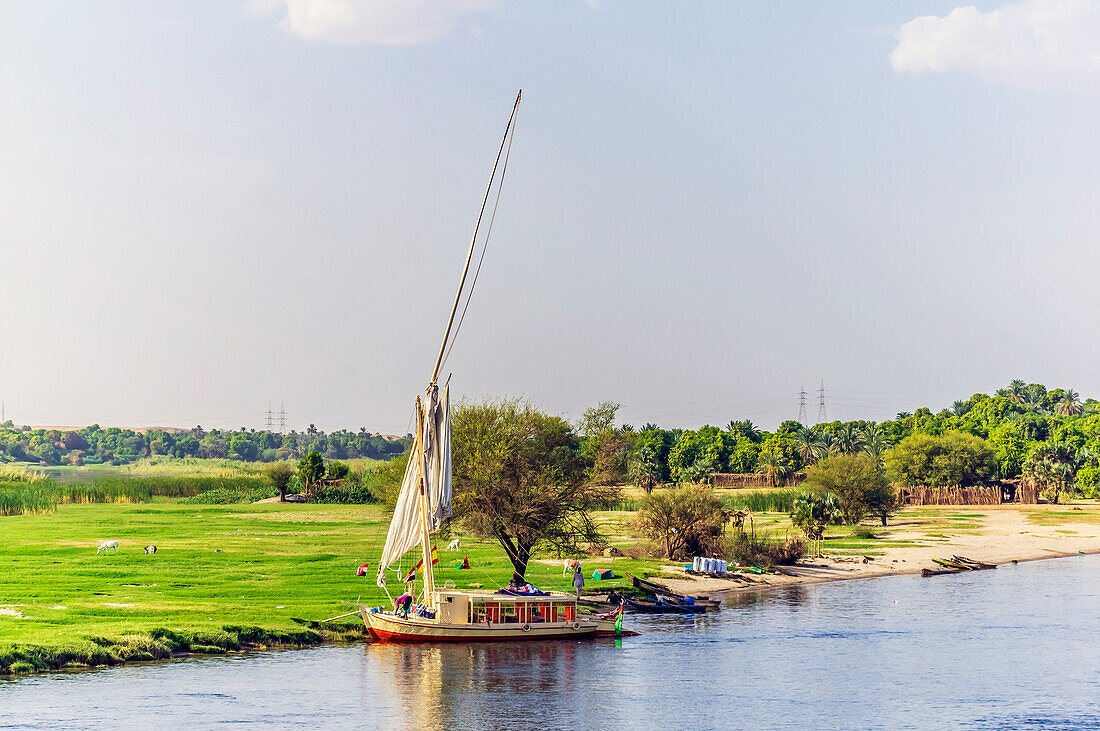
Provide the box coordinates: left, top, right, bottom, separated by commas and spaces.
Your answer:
0, 556, 1100, 729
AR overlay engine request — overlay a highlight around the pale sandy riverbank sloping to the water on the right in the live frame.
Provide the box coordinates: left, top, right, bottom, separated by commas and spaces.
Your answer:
661, 505, 1100, 595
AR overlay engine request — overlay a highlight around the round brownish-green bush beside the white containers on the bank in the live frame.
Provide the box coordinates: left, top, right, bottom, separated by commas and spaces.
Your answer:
635, 485, 726, 560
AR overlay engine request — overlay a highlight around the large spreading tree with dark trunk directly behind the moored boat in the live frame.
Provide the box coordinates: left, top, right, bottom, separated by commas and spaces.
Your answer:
451, 399, 620, 583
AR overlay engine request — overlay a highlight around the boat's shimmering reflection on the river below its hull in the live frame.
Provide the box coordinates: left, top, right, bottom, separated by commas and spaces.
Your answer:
363, 640, 585, 729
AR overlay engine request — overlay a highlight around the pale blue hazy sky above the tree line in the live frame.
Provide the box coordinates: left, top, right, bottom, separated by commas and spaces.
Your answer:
0, 0, 1100, 433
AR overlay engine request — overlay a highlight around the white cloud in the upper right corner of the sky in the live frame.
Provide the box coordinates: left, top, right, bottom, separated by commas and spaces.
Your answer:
890, 0, 1100, 89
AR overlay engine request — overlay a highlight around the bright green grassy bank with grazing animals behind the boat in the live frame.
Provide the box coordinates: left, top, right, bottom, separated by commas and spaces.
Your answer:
0, 501, 661, 673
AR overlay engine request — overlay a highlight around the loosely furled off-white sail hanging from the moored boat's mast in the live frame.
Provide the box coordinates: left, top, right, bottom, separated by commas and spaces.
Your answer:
377, 386, 452, 586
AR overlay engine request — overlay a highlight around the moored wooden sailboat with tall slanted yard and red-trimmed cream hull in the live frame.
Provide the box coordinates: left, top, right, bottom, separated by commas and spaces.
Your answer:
359, 91, 622, 642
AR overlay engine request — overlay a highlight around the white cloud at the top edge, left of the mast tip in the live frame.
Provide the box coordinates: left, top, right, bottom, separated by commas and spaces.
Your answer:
249, 0, 496, 46
